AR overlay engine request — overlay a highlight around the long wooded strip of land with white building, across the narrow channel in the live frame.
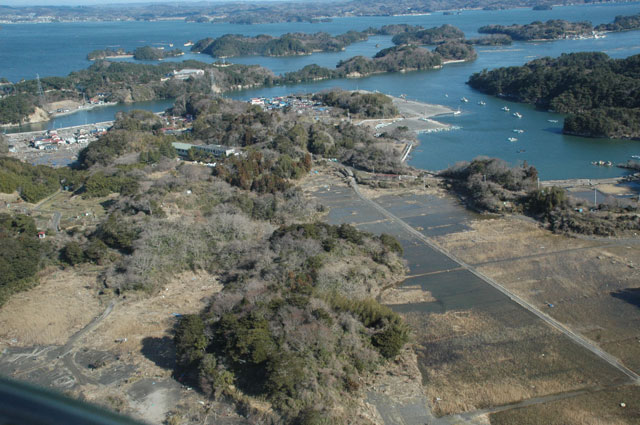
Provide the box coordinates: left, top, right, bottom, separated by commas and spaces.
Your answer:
0, 43, 476, 125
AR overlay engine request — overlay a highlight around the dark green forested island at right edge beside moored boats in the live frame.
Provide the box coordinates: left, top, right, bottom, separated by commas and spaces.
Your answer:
468, 52, 640, 139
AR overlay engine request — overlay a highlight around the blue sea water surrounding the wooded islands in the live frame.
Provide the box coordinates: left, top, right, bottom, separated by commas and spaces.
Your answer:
0, 3, 640, 179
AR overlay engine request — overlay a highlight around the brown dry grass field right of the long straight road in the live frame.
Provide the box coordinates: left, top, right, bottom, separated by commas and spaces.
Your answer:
438, 218, 640, 371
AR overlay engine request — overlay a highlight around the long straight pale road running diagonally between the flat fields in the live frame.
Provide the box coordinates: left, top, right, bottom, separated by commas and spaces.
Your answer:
350, 177, 640, 384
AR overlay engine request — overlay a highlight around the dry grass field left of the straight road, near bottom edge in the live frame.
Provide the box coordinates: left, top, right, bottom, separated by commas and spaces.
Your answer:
405, 309, 622, 416
